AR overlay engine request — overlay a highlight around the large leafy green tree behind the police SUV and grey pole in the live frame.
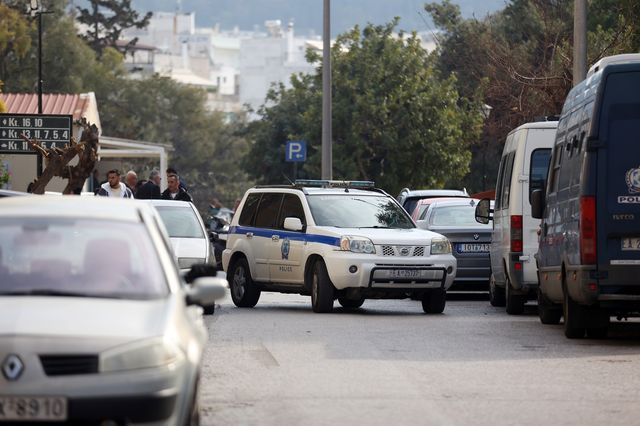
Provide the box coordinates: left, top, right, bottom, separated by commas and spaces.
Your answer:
245, 20, 480, 193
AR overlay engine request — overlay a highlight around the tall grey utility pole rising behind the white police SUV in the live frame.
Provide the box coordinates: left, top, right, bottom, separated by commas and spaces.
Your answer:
322, 0, 333, 180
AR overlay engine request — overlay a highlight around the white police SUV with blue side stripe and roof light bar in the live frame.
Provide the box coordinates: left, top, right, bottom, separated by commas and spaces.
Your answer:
222, 180, 456, 313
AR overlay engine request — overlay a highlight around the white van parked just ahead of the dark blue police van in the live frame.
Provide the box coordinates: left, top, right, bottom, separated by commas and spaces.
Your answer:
476, 121, 558, 314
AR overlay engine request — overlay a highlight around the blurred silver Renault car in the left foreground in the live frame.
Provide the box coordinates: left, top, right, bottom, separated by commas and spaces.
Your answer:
0, 197, 226, 425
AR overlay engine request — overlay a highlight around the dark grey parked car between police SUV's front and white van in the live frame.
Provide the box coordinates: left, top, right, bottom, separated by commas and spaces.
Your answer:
416, 199, 492, 291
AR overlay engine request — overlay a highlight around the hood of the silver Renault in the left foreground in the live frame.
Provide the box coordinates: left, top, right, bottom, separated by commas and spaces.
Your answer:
0, 296, 171, 341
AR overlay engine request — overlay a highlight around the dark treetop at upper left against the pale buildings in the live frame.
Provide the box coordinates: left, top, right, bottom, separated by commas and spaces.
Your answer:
76, 0, 152, 56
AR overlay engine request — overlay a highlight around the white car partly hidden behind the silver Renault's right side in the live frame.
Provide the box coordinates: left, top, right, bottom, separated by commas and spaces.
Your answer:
144, 200, 216, 315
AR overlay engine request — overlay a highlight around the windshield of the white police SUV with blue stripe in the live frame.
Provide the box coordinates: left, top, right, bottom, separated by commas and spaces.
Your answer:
307, 193, 415, 229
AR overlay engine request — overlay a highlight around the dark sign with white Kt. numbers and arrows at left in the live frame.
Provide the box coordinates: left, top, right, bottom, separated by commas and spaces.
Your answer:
0, 114, 73, 154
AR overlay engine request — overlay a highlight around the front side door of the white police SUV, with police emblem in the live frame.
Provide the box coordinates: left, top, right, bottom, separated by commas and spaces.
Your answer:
269, 194, 307, 284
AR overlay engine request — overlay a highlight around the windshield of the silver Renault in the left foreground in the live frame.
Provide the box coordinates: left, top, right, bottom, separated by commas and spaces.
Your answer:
0, 218, 169, 299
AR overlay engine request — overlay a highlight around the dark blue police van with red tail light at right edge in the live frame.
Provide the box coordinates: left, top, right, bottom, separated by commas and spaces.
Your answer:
532, 55, 640, 338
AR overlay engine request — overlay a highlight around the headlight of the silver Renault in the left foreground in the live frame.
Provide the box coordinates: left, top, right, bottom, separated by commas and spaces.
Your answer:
100, 338, 184, 373
